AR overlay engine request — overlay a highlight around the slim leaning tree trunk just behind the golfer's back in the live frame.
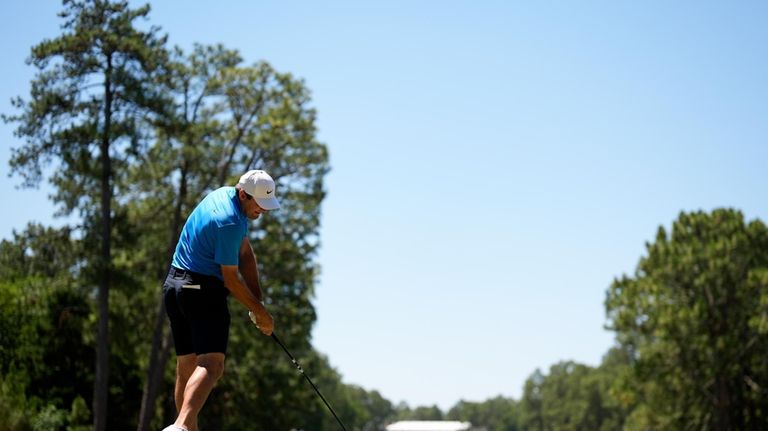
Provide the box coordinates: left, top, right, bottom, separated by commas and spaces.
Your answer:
138, 163, 188, 431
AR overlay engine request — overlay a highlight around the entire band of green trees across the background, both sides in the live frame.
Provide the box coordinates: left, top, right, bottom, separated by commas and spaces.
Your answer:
0, 0, 768, 431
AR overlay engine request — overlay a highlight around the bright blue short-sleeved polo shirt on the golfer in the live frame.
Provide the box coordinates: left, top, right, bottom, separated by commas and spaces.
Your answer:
171, 187, 248, 278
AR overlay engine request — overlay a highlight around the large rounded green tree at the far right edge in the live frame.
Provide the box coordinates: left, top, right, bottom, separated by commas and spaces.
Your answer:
606, 209, 768, 430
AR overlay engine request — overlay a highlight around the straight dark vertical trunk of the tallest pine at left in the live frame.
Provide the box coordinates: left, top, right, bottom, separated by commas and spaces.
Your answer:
93, 55, 112, 431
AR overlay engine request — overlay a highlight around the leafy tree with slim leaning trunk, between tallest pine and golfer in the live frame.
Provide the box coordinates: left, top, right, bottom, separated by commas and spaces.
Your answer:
129, 46, 242, 431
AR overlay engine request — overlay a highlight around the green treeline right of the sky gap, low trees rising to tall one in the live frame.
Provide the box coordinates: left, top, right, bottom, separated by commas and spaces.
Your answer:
388, 209, 768, 431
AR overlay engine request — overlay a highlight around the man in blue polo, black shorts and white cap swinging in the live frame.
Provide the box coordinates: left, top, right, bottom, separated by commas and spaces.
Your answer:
163, 170, 280, 431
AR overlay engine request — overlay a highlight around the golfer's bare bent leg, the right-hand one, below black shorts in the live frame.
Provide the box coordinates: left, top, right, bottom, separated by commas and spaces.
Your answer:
175, 353, 224, 431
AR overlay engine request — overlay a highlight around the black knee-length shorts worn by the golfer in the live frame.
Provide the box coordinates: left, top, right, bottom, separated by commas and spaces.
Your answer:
163, 267, 229, 356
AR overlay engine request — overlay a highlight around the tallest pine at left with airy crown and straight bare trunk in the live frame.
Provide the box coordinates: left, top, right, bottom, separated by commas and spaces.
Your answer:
6, 0, 170, 431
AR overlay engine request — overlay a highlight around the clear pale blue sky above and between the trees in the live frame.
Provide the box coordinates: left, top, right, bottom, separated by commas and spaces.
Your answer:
0, 0, 768, 409
